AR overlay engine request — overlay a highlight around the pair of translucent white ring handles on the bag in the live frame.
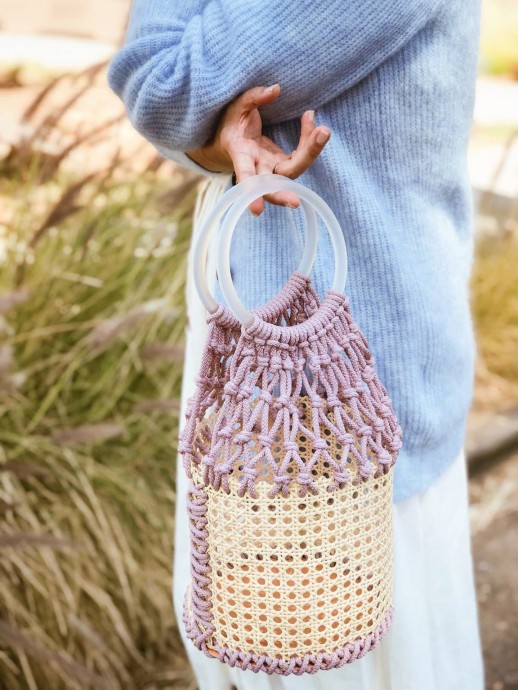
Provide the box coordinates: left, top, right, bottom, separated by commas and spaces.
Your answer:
193, 173, 347, 328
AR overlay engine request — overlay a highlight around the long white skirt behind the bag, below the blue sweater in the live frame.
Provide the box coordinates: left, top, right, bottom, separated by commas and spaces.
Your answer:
173, 175, 484, 690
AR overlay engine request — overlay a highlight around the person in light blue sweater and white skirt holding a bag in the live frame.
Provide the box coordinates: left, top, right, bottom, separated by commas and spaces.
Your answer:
108, 0, 484, 690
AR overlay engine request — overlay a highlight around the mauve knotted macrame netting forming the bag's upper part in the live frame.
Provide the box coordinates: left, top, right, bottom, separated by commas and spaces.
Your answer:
180, 284, 401, 496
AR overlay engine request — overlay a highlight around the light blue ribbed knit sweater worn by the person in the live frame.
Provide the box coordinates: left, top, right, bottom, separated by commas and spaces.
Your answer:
108, 0, 479, 501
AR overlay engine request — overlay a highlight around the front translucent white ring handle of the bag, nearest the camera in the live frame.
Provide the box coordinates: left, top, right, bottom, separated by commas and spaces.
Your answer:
216, 173, 347, 328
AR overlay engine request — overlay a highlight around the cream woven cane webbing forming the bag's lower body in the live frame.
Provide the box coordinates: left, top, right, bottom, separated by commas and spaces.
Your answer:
188, 399, 393, 659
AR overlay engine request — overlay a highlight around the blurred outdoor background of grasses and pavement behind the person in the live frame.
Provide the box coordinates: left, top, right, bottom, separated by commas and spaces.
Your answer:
0, 0, 518, 690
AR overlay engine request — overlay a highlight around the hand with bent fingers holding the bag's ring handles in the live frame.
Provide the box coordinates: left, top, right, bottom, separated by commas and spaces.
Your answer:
186, 84, 331, 216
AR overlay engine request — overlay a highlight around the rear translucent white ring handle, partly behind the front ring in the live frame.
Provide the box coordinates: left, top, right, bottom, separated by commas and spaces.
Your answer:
193, 180, 318, 314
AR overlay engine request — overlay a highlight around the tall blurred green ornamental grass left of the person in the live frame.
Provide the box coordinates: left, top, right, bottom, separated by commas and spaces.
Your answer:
0, 165, 199, 690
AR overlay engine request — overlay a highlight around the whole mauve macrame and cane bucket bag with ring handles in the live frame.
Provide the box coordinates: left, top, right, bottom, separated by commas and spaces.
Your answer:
180, 174, 401, 675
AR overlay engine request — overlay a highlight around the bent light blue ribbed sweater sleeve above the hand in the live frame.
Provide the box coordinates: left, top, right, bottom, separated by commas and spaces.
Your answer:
108, 0, 444, 151
